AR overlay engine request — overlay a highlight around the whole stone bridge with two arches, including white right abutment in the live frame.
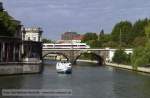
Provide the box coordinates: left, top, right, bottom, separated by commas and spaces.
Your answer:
42, 48, 133, 65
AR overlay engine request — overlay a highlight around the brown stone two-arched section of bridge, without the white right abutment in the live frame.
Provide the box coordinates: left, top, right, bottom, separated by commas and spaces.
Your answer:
42, 49, 108, 64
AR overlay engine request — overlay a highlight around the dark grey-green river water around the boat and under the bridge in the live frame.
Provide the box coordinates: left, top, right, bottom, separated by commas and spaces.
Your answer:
0, 60, 150, 98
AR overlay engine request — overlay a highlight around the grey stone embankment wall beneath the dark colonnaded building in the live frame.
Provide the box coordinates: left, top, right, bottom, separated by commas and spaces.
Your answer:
0, 62, 42, 75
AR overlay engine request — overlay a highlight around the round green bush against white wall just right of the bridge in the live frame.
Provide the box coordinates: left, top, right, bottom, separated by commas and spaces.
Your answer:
112, 49, 130, 64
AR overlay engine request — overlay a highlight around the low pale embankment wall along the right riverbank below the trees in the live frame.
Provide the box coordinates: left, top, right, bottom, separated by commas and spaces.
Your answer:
105, 63, 150, 73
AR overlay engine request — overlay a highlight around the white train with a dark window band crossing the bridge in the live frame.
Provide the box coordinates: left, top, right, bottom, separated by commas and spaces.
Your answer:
43, 43, 90, 49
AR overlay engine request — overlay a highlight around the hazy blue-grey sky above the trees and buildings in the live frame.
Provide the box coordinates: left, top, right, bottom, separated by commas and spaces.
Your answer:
0, 0, 150, 40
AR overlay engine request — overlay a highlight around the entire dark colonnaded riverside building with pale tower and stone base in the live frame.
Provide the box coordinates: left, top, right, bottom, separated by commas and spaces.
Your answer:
0, 2, 42, 75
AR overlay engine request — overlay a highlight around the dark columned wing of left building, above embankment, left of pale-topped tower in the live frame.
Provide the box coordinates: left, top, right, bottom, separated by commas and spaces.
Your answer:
0, 2, 22, 62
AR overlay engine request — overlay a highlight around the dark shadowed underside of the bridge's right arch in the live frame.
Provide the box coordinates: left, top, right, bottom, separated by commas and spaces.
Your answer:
74, 52, 104, 65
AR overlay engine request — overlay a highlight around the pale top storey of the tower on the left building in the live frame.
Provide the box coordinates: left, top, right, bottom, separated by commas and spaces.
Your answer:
23, 27, 43, 42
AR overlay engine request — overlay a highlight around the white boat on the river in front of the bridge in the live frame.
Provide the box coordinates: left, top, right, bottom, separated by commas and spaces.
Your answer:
56, 62, 72, 74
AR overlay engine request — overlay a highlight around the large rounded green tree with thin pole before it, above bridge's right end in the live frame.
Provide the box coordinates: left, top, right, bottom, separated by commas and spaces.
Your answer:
111, 21, 132, 44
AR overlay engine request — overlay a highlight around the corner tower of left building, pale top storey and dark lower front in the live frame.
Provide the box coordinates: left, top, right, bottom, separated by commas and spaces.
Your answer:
22, 27, 43, 62
